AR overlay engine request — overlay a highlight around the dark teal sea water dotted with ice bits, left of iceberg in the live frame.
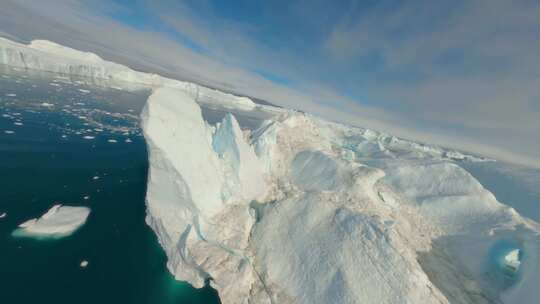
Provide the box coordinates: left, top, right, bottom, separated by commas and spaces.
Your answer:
0, 69, 219, 304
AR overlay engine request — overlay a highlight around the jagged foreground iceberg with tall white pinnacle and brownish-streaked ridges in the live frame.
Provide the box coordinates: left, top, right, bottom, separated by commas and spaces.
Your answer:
139, 89, 452, 303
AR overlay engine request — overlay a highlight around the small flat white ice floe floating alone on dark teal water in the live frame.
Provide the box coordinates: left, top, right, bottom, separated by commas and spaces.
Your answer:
14, 204, 90, 237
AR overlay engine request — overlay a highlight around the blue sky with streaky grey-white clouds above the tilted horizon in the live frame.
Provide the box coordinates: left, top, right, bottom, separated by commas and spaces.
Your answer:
0, 0, 540, 167
